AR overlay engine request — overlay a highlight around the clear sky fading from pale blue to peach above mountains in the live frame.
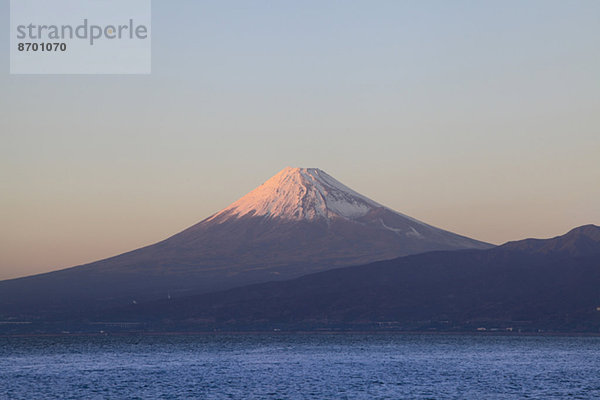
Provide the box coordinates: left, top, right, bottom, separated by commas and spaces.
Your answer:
0, 0, 600, 279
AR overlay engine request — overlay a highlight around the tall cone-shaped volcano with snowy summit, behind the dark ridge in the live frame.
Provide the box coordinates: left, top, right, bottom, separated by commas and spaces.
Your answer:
0, 168, 491, 316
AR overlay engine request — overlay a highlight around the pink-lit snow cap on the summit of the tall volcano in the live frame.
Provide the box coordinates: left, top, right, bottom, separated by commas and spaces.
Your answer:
210, 167, 382, 220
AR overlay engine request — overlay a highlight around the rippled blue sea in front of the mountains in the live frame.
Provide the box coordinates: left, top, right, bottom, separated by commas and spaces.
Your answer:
0, 333, 600, 400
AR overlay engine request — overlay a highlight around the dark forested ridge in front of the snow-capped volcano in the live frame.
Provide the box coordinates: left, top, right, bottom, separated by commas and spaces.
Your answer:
105, 225, 600, 332
